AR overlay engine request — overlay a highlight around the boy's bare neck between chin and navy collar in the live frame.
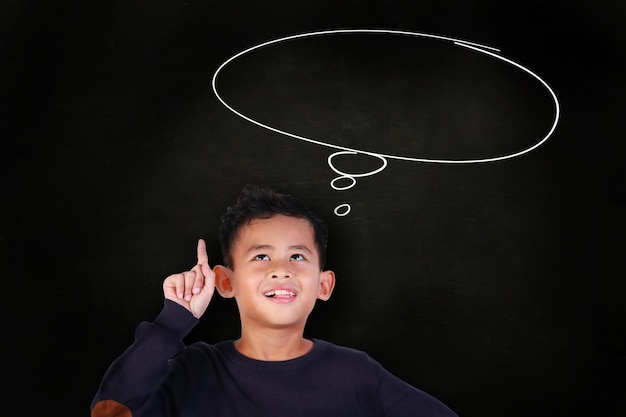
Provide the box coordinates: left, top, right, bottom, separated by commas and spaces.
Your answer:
235, 329, 313, 362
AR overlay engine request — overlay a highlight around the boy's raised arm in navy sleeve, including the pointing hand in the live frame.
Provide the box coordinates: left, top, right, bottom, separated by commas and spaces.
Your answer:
91, 239, 215, 417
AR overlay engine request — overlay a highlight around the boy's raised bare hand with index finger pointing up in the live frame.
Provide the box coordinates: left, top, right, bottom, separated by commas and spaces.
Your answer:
163, 239, 215, 318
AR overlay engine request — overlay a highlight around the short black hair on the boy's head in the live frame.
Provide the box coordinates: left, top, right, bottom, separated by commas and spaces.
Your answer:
219, 185, 328, 270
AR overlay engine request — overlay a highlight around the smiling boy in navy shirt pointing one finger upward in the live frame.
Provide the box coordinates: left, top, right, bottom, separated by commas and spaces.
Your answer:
91, 187, 456, 417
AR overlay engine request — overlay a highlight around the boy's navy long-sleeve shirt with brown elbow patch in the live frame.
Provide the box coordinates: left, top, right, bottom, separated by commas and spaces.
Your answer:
91, 300, 456, 417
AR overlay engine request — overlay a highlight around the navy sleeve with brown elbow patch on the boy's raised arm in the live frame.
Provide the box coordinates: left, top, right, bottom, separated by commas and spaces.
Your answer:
91, 300, 198, 417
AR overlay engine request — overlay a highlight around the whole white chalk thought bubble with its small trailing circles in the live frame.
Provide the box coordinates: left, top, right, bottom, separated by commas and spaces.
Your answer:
212, 29, 560, 216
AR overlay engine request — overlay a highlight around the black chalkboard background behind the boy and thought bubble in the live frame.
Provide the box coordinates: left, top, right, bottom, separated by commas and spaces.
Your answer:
0, 0, 626, 417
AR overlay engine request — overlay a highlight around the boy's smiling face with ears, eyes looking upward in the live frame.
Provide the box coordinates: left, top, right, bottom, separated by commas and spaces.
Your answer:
216, 215, 335, 328
